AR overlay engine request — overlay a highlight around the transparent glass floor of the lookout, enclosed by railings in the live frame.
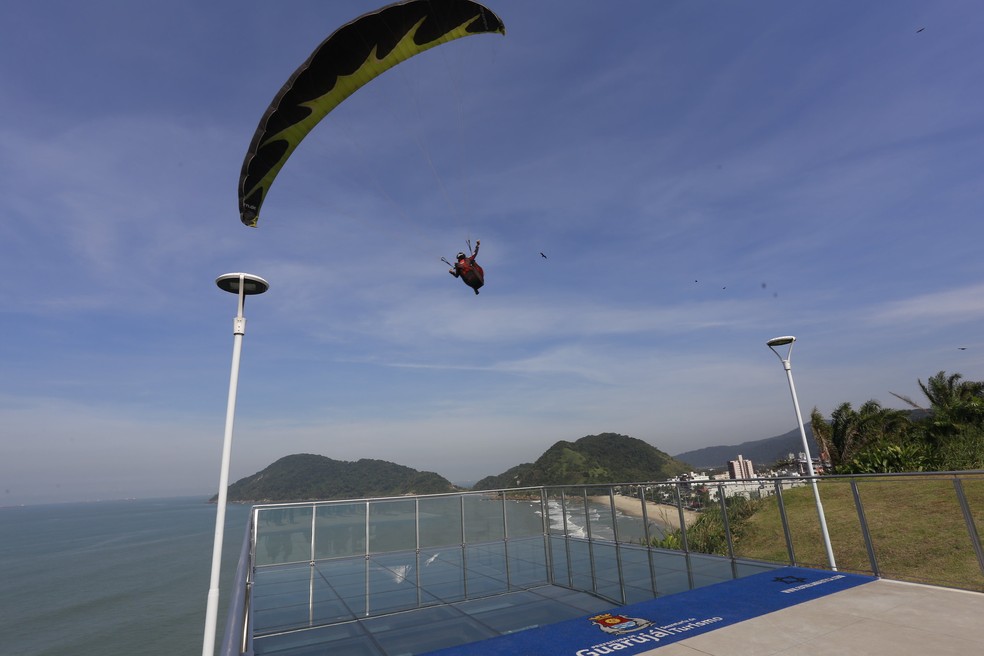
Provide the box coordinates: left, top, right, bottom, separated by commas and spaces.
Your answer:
251, 538, 780, 656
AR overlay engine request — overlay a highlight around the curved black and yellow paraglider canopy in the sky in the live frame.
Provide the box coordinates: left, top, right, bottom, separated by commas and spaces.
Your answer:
239, 0, 505, 227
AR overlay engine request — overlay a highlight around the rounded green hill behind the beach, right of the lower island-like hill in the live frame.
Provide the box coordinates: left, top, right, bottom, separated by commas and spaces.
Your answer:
474, 433, 690, 490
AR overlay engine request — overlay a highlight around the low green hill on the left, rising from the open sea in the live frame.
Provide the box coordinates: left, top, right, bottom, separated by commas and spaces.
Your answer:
219, 453, 455, 502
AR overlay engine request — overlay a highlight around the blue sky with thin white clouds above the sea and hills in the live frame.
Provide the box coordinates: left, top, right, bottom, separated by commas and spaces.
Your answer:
0, 0, 984, 504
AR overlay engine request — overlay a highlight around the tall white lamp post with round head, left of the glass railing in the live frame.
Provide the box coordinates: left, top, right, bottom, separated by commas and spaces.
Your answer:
202, 273, 270, 656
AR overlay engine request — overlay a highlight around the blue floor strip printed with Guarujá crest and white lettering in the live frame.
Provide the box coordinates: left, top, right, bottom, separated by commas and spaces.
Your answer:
428, 567, 875, 656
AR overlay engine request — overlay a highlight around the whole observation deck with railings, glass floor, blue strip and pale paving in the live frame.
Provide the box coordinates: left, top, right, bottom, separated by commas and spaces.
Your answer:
220, 475, 984, 656
